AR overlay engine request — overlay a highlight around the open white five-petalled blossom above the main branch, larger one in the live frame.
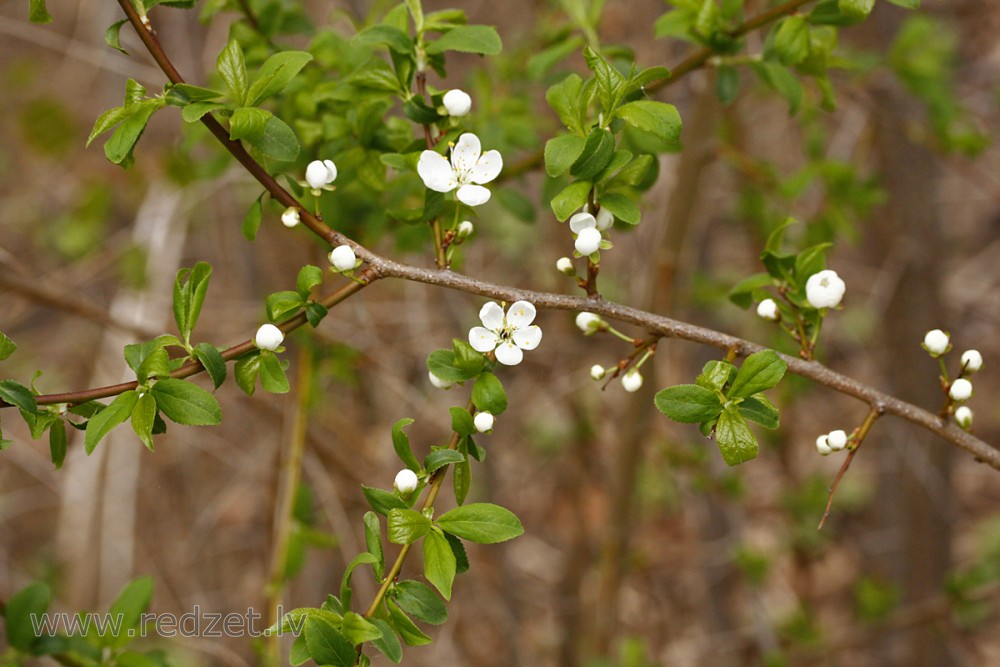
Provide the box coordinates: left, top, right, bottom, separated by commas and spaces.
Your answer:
417, 132, 503, 206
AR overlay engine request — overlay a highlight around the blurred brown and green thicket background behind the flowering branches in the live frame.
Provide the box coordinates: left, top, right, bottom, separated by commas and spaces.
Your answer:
0, 0, 1000, 667
